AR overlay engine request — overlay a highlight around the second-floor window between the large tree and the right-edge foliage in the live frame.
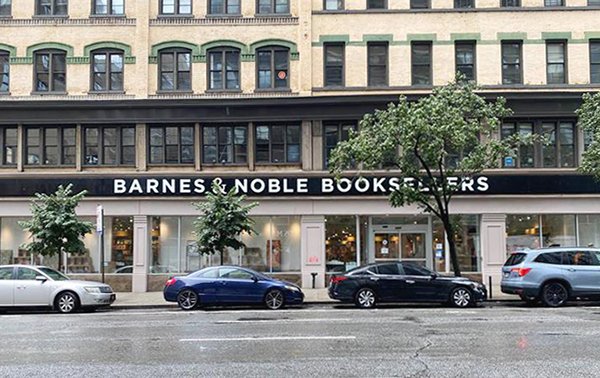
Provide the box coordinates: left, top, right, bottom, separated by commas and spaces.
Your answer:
502, 121, 576, 168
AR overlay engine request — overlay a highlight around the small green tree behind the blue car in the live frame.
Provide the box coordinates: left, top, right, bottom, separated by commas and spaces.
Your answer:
192, 180, 258, 265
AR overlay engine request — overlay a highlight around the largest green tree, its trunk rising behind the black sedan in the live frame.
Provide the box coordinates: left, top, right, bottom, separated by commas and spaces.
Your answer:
330, 78, 524, 276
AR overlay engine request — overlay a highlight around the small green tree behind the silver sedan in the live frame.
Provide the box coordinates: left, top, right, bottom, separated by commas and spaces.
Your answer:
19, 184, 94, 266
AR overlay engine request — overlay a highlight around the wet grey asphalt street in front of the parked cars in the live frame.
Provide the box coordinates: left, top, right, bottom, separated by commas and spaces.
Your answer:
0, 302, 600, 377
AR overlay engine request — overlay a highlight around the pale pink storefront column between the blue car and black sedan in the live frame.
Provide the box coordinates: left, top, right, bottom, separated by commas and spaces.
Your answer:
300, 216, 325, 289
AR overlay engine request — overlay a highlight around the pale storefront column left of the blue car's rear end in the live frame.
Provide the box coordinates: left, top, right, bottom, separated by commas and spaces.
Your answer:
131, 215, 150, 293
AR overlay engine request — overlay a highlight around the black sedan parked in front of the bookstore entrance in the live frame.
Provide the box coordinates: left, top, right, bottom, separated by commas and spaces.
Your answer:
329, 262, 487, 308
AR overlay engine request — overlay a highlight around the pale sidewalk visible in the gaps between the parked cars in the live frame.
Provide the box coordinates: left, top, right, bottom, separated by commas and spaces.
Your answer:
111, 289, 518, 309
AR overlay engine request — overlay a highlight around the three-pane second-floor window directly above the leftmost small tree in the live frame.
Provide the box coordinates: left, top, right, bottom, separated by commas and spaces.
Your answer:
25, 127, 75, 166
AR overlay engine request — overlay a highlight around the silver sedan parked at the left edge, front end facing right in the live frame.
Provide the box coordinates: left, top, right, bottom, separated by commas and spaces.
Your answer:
0, 265, 116, 313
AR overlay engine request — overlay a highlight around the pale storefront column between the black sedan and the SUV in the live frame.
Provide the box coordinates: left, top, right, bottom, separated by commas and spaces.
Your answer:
481, 214, 506, 296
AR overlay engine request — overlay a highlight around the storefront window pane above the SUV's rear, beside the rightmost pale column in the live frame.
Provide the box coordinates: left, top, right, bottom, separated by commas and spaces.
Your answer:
506, 214, 540, 254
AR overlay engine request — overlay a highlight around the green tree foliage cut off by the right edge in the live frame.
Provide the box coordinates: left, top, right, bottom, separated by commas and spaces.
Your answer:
575, 92, 600, 180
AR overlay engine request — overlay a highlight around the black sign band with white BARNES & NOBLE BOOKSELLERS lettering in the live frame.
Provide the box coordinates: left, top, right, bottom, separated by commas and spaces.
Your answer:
0, 174, 600, 198
